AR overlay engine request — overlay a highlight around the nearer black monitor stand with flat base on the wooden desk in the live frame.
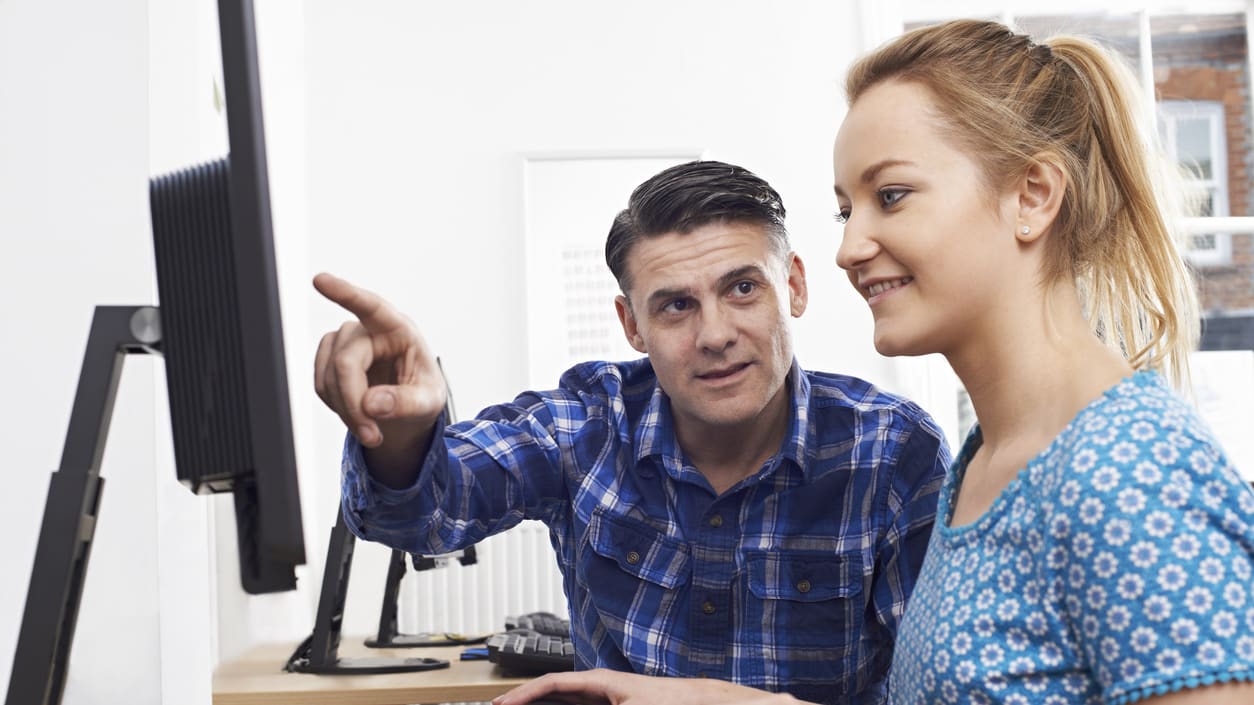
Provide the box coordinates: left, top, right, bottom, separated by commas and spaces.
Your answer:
286, 508, 449, 675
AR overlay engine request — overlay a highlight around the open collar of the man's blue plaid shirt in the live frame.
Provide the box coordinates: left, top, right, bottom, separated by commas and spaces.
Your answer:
636, 358, 818, 482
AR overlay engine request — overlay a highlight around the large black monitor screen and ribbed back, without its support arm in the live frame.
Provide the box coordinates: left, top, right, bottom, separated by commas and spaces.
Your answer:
149, 0, 305, 593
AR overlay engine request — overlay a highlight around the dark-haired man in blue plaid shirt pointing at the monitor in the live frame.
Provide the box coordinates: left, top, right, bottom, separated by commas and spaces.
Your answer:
315, 162, 949, 702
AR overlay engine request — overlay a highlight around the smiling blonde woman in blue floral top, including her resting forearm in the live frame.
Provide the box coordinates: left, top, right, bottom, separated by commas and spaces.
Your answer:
498, 20, 1254, 705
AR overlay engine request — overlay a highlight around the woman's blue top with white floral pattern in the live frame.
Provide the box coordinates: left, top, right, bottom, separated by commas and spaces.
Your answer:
889, 373, 1254, 705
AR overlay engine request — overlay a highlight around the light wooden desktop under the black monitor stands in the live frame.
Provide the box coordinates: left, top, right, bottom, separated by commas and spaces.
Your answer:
213, 637, 528, 705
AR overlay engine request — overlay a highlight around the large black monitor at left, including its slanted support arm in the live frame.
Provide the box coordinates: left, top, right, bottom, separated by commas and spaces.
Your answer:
6, 0, 305, 705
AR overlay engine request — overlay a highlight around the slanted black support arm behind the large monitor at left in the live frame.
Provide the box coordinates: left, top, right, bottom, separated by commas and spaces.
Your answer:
5, 306, 161, 705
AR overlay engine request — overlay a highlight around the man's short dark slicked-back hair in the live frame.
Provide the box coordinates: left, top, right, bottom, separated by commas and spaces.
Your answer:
606, 161, 791, 295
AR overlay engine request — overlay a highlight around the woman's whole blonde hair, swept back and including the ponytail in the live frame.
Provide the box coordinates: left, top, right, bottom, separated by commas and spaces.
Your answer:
845, 20, 1199, 385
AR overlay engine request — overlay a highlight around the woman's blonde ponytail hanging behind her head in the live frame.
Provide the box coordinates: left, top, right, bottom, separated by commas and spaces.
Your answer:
1048, 36, 1200, 386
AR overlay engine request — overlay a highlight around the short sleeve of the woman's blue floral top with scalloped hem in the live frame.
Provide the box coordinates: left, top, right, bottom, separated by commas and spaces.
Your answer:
1038, 373, 1254, 702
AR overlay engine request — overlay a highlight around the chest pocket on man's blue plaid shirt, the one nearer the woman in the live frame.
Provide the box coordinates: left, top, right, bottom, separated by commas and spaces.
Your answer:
745, 551, 865, 664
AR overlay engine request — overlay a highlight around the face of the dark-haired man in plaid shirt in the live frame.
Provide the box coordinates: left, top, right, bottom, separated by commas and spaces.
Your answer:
614, 222, 806, 434
